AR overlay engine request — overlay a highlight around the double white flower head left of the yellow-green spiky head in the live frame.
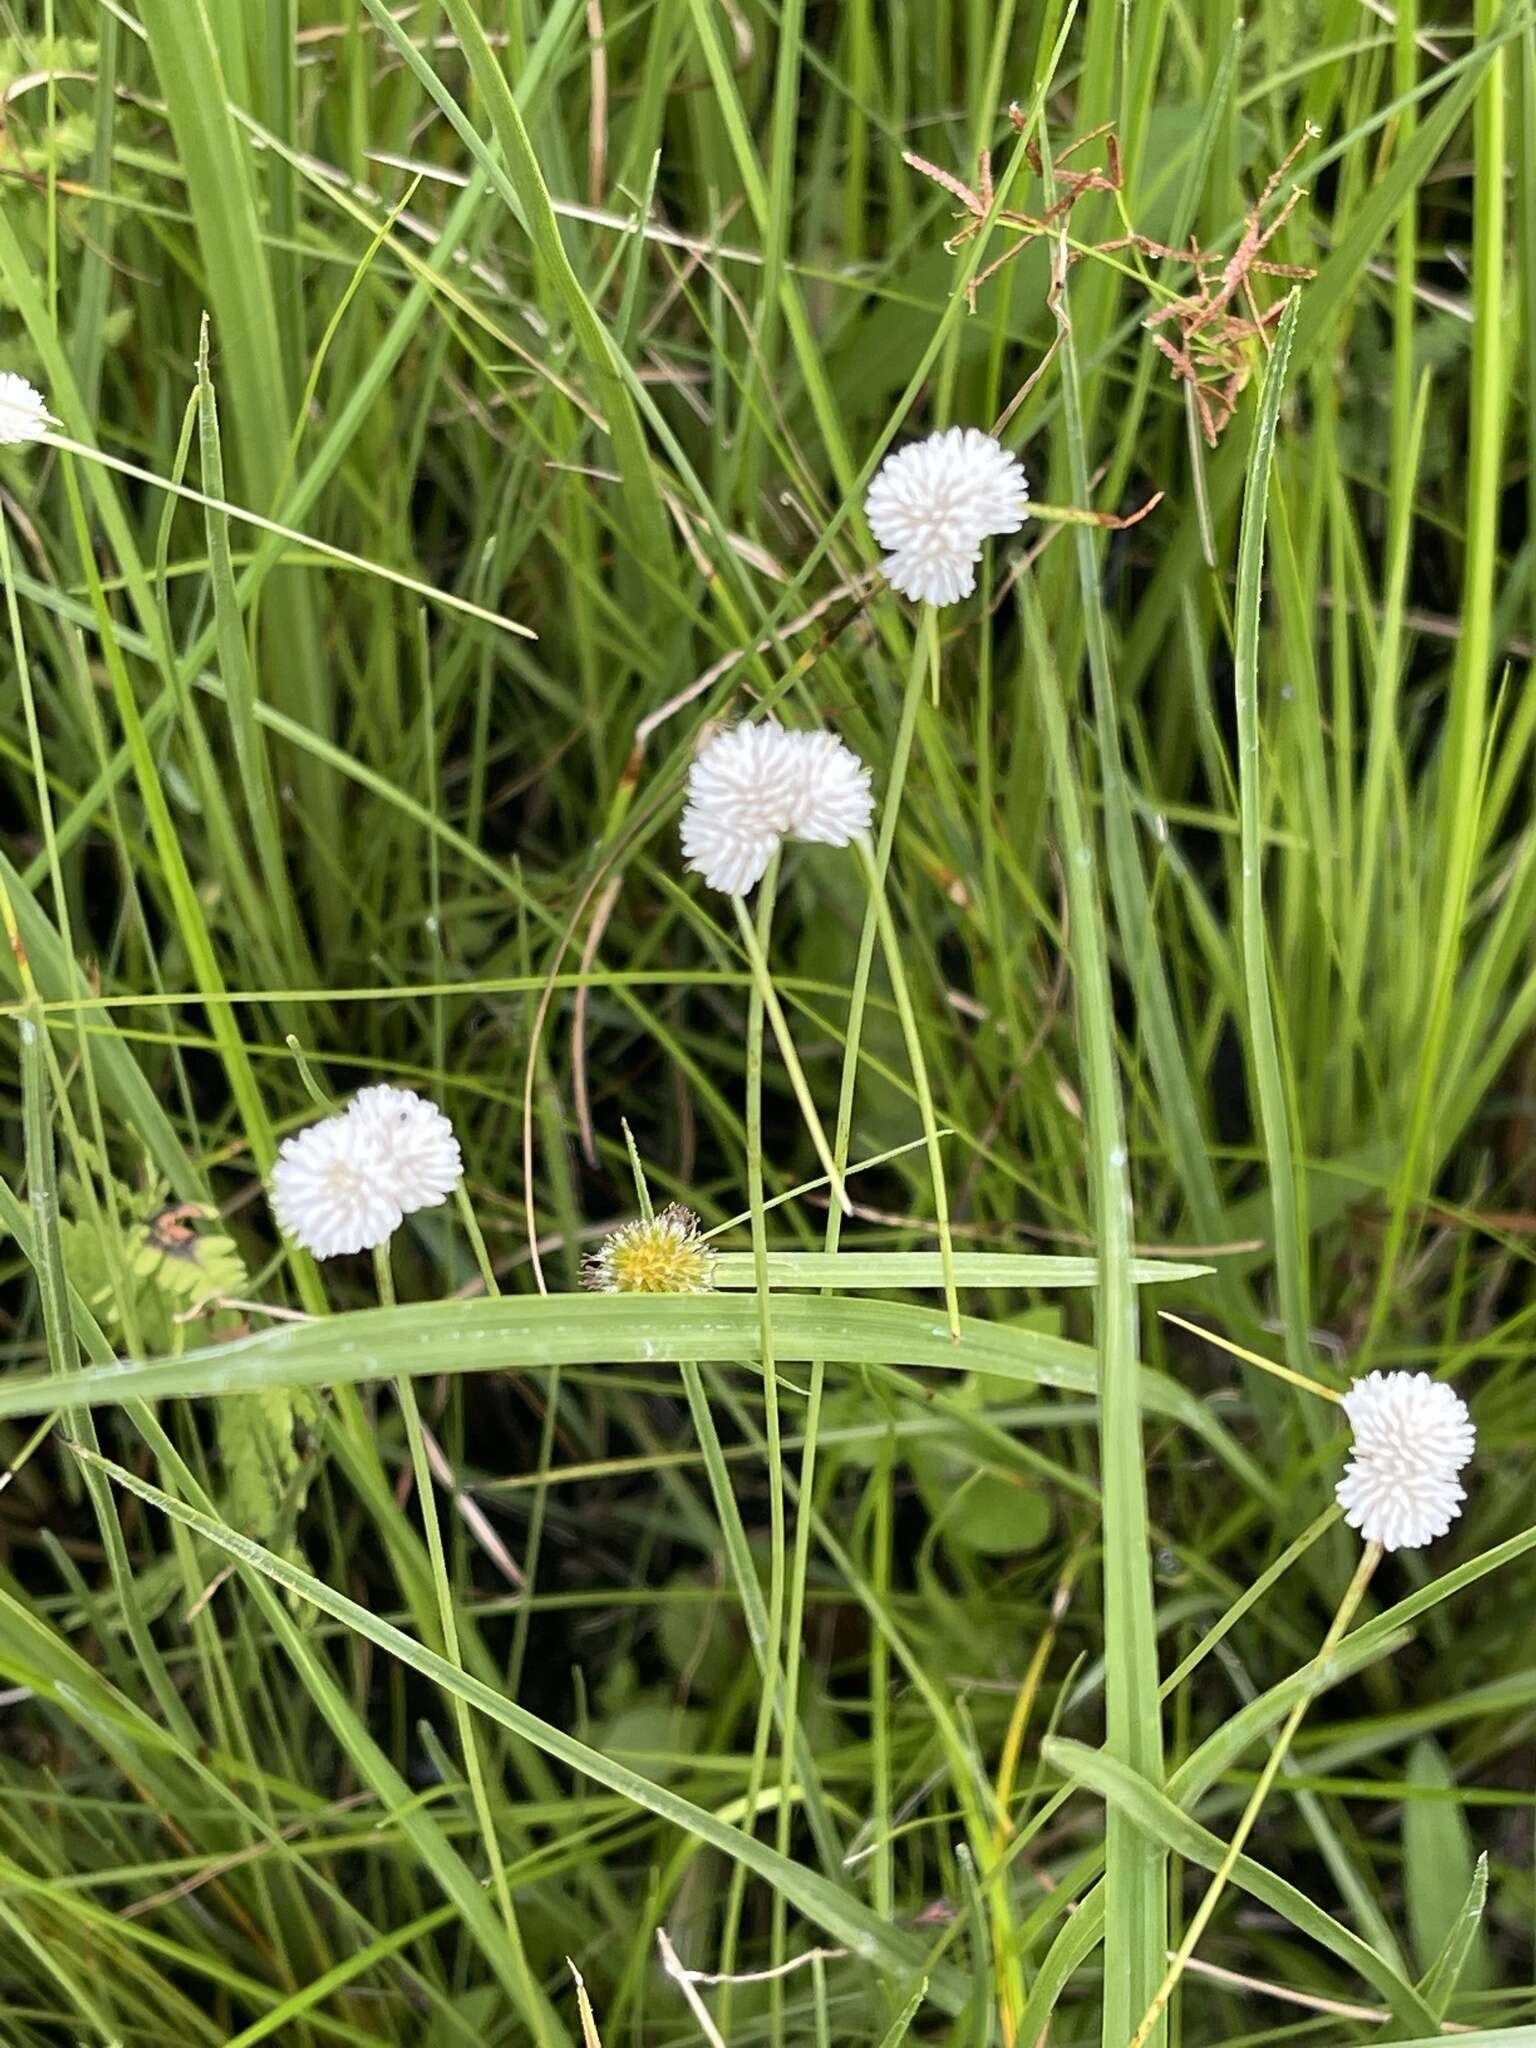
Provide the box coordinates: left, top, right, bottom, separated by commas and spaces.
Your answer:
272, 1087, 465, 1260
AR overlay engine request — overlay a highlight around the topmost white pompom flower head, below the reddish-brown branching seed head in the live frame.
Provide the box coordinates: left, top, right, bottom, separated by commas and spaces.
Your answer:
864, 426, 1030, 604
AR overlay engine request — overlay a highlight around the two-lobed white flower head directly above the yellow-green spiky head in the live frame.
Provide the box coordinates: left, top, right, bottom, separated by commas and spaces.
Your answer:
682, 719, 874, 895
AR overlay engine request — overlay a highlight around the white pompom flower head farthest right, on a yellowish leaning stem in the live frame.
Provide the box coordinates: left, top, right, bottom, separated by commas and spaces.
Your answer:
1335, 1372, 1477, 1550
